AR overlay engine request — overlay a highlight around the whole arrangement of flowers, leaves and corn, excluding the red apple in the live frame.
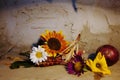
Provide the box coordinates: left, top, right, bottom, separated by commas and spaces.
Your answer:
10, 30, 118, 80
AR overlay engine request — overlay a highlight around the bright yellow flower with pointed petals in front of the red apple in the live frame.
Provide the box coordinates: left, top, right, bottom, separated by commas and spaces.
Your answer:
86, 52, 111, 74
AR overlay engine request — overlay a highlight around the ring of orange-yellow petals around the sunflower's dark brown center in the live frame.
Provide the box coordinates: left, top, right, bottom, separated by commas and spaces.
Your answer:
42, 30, 68, 57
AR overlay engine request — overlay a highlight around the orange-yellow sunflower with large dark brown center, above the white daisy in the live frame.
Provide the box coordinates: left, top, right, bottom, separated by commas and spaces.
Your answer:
41, 30, 68, 57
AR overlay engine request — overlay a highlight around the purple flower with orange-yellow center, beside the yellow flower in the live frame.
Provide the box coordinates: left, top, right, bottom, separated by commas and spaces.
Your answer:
66, 51, 84, 76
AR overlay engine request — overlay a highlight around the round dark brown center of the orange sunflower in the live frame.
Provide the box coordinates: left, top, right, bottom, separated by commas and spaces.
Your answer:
48, 38, 61, 50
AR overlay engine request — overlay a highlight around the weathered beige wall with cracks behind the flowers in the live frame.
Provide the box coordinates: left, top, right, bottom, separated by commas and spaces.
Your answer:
0, 0, 120, 52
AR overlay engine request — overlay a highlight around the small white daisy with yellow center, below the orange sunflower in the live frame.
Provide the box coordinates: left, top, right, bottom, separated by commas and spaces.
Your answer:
30, 46, 48, 65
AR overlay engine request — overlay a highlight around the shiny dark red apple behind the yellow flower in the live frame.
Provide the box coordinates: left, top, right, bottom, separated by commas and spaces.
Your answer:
96, 45, 119, 66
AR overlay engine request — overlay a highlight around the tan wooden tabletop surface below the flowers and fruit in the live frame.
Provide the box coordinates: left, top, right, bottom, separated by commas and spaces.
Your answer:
0, 61, 120, 80
